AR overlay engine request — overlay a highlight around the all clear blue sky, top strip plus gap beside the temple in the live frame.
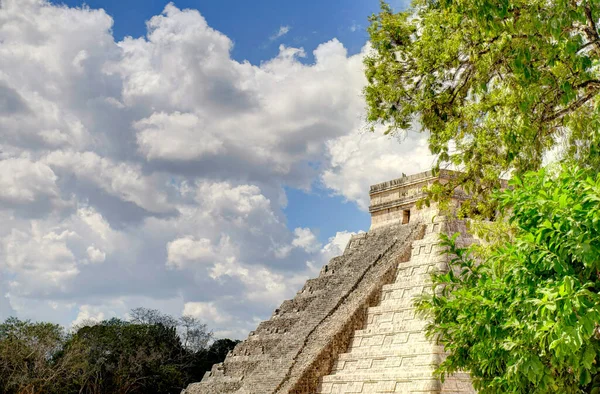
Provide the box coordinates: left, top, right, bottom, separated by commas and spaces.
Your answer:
48, 0, 402, 243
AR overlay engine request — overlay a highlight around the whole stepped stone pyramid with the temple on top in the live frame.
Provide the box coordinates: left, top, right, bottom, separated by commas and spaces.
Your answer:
182, 171, 475, 394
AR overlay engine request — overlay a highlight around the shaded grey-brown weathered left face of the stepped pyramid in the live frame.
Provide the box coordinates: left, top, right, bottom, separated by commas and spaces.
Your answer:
185, 223, 424, 394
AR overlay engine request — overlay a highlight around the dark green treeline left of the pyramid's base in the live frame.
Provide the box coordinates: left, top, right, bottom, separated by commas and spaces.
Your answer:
0, 308, 238, 394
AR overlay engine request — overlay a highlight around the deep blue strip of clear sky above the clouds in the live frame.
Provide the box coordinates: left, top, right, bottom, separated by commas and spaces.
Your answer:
53, 0, 404, 64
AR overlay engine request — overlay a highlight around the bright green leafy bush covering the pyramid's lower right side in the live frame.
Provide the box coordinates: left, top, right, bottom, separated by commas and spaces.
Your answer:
417, 165, 600, 393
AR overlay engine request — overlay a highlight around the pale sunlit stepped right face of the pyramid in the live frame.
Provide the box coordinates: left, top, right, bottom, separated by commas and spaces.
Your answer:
318, 217, 475, 394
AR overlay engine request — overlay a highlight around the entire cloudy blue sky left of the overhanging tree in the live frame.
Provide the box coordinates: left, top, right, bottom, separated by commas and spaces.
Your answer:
0, 0, 432, 338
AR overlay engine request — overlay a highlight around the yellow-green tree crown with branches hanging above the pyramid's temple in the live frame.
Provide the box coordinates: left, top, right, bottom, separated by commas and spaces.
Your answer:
365, 0, 600, 214
